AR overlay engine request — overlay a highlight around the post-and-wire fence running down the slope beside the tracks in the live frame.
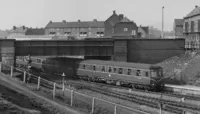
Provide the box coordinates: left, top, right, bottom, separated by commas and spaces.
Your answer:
0, 64, 150, 114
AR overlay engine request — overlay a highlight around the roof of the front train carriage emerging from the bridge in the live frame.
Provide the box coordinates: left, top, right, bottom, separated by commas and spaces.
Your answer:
81, 60, 160, 69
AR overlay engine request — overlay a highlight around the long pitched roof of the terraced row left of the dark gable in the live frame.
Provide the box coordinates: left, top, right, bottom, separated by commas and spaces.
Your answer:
45, 20, 104, 28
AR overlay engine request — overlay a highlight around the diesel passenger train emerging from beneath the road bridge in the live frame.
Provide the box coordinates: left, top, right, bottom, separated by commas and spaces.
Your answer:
17, 56, 165, 90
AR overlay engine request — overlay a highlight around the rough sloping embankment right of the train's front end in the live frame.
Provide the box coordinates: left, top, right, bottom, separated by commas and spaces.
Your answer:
159, 52, 200, 86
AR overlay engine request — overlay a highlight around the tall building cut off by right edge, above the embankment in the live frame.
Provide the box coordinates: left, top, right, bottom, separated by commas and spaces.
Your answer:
183, 6, 200, 50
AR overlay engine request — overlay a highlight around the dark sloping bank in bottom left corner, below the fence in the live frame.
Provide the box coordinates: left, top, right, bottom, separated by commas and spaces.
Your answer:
0, 73, 82, 114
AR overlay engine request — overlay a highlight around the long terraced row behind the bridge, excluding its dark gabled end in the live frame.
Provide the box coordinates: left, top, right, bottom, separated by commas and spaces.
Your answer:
45, 19, 104, 39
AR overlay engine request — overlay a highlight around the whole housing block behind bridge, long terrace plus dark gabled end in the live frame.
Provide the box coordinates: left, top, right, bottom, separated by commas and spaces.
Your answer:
45, 11, 138, 39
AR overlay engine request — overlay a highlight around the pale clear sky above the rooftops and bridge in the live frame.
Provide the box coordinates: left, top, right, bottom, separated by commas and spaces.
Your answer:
0, 0, 200, 30
